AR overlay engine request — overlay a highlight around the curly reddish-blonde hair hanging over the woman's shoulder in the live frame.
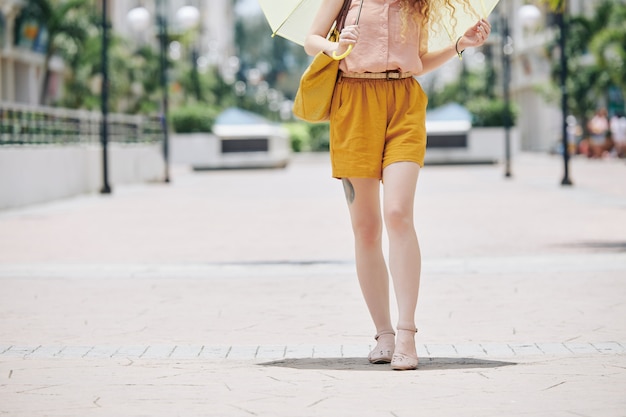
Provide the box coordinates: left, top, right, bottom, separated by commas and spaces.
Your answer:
400, 0, 479, 39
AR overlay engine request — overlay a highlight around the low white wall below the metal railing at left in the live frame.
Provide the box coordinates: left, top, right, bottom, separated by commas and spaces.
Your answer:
0, 144, 165, 209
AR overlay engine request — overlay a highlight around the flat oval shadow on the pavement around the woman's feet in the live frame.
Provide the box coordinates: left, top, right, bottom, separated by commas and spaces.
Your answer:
259, 357, 517, 371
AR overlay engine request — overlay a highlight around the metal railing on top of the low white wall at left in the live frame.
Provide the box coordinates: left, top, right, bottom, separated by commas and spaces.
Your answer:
0, 102, 163, 146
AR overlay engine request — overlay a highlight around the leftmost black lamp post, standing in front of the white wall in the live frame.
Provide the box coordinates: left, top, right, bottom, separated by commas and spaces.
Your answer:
100, 0, 111, 194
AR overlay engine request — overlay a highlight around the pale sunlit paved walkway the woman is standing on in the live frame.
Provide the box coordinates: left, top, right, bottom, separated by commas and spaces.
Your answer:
0, 155, 626, 417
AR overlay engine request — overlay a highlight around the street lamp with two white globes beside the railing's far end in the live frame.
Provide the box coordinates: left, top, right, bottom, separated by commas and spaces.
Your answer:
125, 0, 199, 182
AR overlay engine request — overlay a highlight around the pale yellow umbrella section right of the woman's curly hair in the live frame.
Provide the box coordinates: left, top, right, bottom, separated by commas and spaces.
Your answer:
428, 0, 498, 51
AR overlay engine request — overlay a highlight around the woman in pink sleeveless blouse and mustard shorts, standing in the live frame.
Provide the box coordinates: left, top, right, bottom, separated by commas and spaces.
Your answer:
305, 0, 491, 370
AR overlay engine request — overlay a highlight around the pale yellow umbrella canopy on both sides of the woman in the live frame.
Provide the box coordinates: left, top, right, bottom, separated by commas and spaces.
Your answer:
259, 0, 498, 50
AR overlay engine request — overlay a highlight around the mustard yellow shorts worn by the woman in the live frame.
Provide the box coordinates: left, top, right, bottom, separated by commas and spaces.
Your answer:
330, 77, 428, 179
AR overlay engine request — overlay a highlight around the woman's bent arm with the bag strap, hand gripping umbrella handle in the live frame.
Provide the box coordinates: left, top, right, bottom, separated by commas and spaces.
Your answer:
304, 0, 358, 56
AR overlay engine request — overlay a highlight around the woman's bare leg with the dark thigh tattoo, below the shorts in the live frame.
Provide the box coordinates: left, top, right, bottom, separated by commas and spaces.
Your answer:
342, 178, 393, 336
